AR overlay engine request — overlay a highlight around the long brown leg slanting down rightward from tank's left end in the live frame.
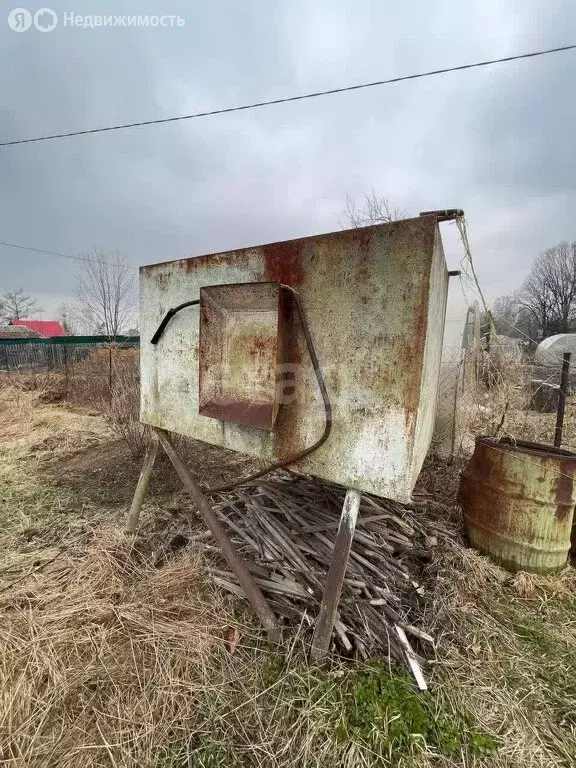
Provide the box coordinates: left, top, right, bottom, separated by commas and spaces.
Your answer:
154, 428, 279, 642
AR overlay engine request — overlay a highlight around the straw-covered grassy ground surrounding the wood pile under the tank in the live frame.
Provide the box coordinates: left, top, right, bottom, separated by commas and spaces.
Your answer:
0, 387, 576, 768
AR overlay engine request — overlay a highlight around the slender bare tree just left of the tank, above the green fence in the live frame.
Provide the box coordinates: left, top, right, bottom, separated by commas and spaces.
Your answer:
75, 249, 137, 338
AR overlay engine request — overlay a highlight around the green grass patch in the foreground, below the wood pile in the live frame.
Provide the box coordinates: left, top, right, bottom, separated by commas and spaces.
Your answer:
209, 654, 498, 766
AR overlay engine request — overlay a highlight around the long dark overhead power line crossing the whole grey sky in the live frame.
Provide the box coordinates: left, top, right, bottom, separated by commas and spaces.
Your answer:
0, 43, 576, 147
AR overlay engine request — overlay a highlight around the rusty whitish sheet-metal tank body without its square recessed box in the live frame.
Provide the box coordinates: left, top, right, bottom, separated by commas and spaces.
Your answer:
140, 217, 447, 501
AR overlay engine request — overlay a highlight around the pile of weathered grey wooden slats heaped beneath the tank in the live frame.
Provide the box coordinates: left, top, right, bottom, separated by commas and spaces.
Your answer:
196, 475, 450, 660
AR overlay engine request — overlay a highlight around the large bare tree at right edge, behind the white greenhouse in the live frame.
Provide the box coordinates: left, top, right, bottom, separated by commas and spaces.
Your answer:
518, 241, 576, 338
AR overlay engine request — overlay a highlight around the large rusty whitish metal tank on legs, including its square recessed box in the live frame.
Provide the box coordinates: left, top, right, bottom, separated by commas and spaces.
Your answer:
140, 213, 448, 502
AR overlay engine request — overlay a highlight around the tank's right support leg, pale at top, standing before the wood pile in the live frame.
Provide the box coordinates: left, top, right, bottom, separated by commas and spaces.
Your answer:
310, 490, 361, 661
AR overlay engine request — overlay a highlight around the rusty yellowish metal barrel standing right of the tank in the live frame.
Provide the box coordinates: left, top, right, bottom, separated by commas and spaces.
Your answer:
460, 437, 576, 573
